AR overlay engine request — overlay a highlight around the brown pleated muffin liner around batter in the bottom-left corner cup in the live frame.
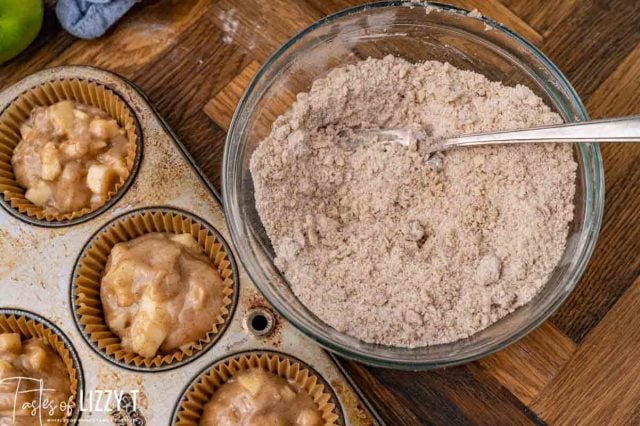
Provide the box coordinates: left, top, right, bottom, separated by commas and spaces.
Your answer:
0, 309, 82, 423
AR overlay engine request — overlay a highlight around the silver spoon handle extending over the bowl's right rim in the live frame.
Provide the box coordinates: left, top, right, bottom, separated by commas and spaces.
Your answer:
442, 116, 640, 149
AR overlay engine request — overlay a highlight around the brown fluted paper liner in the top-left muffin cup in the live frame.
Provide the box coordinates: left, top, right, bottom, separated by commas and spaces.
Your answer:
0, 78, 139, 222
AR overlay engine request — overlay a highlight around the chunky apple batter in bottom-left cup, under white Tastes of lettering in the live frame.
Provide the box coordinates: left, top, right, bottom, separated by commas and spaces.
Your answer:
0, 333, 71, 426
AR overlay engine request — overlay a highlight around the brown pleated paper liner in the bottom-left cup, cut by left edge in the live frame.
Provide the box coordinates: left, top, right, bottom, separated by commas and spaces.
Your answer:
0, 314, 78, 418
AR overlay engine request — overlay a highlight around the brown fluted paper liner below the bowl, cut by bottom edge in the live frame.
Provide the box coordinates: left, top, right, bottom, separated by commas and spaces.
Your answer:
175, 351, 342, 426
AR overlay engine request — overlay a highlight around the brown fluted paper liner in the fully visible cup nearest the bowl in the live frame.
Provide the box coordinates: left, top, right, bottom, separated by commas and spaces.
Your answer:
72, 208, 235, 369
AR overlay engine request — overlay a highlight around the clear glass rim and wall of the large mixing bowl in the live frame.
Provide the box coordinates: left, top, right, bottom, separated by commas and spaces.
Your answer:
222, 0, 604, 371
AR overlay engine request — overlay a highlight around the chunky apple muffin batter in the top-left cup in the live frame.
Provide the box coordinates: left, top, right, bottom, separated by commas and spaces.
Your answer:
11, 101, 129, 213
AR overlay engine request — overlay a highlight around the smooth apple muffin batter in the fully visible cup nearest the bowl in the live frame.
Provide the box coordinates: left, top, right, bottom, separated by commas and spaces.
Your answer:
100, 233, 224, 357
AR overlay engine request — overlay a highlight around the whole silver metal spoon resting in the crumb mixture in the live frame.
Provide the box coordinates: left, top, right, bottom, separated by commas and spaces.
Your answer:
342, 116, 640, 153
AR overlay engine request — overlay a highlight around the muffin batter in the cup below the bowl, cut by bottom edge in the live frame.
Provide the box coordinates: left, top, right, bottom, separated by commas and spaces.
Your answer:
200, 368, 324, 426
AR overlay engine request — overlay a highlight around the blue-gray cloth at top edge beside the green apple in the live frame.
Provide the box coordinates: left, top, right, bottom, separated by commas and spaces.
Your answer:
56, 0, 136, 39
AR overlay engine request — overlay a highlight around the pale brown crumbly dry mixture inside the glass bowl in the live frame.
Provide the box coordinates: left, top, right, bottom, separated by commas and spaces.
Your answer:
251, 56, 577, 347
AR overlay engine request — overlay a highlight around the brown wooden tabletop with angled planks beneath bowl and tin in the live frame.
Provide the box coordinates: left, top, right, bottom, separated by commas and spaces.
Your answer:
0, 0, 640, 425
